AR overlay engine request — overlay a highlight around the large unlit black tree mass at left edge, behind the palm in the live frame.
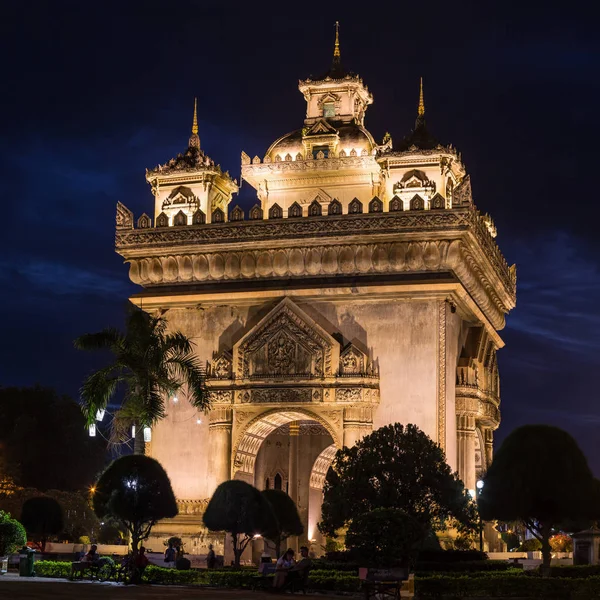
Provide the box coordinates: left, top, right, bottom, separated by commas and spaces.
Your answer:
0, 386, 105, 490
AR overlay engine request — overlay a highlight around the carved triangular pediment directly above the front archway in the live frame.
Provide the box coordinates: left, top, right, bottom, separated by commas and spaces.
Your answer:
233, 298, 339, 378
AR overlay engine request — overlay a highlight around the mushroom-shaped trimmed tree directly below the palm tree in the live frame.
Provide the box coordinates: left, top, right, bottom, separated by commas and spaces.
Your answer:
92, 454, 178, 556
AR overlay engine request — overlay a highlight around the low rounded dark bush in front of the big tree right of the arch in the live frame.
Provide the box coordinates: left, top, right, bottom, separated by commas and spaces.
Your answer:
346, 508, 424, 567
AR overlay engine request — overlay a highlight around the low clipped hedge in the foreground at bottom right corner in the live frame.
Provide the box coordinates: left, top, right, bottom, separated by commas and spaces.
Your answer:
415, 574, 600, 600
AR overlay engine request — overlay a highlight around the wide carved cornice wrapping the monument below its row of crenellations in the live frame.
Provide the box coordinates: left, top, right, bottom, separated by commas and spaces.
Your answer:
116, 208, 515, 329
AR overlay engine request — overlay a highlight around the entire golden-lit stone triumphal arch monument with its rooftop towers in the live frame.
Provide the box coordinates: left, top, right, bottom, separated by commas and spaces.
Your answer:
116, 30, 516, 552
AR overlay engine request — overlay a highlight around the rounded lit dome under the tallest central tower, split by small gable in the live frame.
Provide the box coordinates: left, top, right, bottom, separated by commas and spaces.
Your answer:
265, 123, 376, 160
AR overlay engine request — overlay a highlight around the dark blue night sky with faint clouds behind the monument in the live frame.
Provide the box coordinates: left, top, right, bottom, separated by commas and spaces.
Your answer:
0, 0, 600, 475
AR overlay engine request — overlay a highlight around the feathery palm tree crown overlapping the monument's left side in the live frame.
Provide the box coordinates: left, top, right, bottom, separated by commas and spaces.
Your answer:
74, 308, 209, 454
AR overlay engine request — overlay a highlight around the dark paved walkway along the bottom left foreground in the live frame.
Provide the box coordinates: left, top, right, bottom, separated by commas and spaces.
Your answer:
0, 574, 341, 600
